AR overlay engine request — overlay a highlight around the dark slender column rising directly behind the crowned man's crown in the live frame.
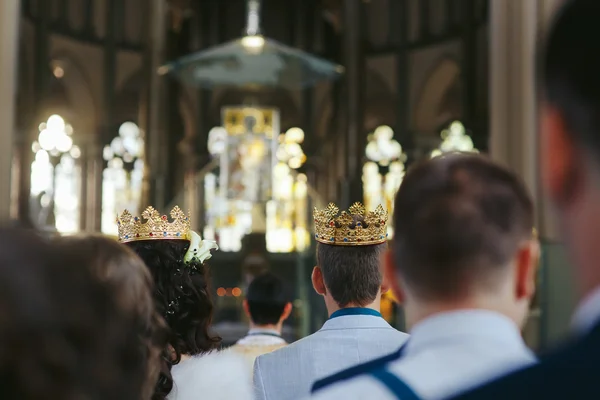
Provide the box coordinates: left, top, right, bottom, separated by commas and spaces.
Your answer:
339, 0, 366, 208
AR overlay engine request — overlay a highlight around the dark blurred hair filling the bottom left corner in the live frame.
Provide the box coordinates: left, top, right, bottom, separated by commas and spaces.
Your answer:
0, 228, 147, 400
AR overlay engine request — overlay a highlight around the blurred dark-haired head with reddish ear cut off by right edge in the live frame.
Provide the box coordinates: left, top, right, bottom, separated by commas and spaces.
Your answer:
539, 0, 600, 294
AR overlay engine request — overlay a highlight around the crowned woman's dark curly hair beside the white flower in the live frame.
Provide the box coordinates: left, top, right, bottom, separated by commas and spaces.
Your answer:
127, 240, 221, 400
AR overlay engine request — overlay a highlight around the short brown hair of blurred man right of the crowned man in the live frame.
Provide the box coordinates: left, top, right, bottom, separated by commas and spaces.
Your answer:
392, 154, 534, 300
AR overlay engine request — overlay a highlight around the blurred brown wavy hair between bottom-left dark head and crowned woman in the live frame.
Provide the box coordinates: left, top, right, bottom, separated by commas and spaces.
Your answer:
55, 236, 167, 399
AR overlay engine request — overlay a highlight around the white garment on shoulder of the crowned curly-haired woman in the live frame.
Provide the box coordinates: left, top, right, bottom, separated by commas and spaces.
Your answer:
167, 351, 253, 400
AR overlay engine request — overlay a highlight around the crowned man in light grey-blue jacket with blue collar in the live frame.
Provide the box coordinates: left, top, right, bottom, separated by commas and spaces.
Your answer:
254, 203, 408, 400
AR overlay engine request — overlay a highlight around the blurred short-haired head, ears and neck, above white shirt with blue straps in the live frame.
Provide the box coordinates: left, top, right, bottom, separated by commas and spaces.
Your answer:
386, 154, 539, 324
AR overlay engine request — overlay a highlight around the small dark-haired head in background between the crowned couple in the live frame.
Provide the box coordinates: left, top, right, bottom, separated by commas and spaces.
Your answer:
244, 272, 292, 329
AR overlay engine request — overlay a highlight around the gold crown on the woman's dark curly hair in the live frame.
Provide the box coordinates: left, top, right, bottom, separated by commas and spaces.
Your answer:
117, 206, 190, 243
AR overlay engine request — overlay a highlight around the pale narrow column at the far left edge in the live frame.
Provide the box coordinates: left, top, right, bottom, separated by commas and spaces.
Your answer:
0, 0, 21, 221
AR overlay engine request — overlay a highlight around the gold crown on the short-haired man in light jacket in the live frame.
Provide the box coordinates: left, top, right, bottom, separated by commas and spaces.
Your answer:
313, 203, 388, 246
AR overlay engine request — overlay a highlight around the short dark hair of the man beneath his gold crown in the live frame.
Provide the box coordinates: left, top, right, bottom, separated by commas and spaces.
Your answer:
317, 239, 387, 307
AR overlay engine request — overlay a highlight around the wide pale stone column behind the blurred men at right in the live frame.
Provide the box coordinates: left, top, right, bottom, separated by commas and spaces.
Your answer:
489, 0, 560, 239
